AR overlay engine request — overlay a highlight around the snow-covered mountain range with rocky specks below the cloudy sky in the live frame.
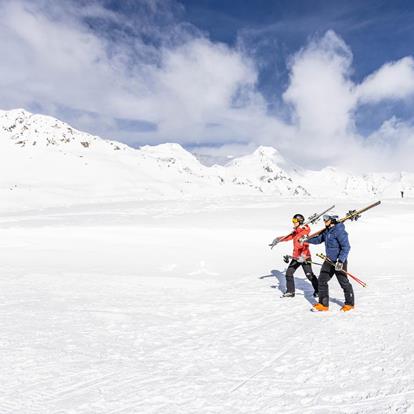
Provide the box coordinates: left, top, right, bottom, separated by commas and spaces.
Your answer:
0, 109, 414, 210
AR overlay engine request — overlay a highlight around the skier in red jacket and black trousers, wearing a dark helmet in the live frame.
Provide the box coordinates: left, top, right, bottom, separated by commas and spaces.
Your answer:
274, 214, 318, 298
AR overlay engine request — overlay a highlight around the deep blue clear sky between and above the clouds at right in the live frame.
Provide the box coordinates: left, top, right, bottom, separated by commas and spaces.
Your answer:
183, 0, 414, 135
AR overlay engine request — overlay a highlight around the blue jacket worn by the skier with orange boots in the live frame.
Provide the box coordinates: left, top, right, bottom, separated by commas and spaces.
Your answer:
306, 223, 351, 262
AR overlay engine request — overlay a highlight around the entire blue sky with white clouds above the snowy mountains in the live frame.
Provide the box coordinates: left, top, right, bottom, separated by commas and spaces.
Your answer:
0, 0, 414, 172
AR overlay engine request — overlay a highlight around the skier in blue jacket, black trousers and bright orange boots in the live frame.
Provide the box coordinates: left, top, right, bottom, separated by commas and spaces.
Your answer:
306, 215, 354, 312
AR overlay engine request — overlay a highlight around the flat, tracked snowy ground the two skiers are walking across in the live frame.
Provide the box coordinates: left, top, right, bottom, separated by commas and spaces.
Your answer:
0, 198, 414, 414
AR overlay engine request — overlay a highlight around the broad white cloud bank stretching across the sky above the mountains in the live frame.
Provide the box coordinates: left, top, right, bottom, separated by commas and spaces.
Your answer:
0, 0, 414, 169
